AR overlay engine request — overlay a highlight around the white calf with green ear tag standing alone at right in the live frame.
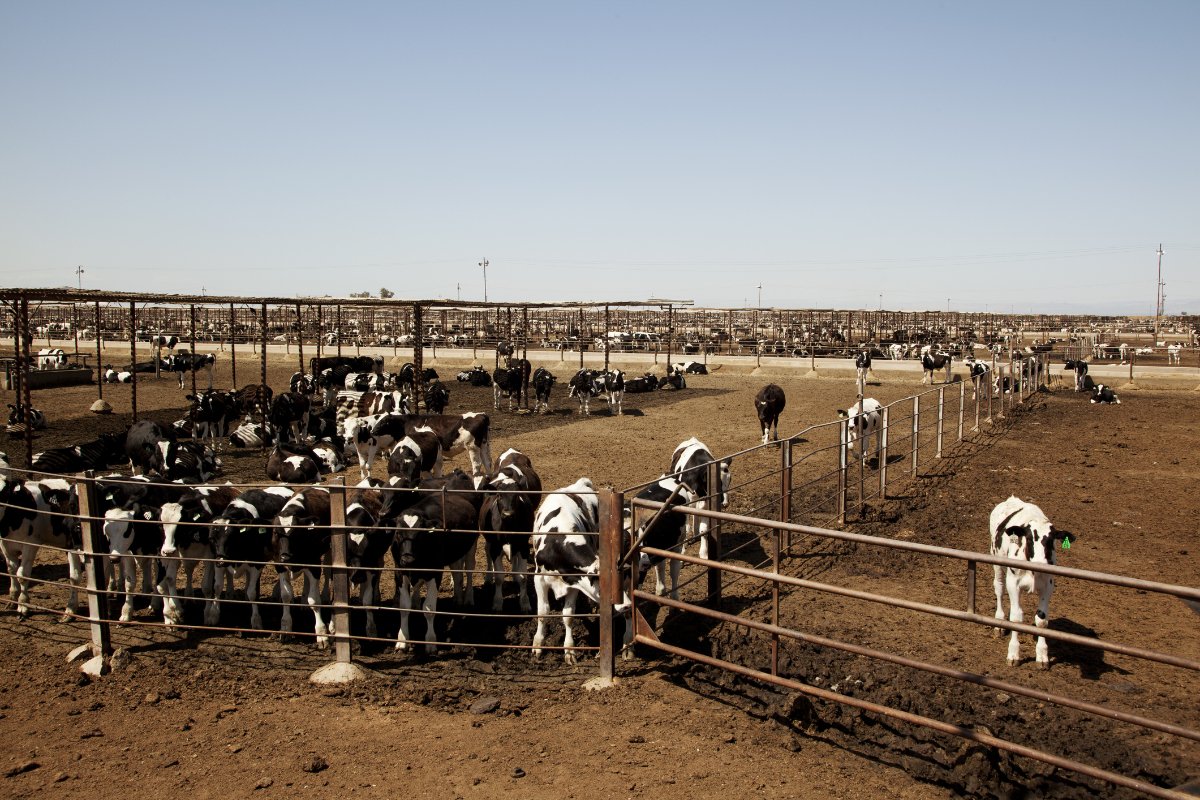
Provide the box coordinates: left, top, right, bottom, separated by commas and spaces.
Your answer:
988, 497, 1075, 669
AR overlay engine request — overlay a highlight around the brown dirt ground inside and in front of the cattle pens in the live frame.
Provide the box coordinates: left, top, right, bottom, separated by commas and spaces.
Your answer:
0, 362, 1200, 800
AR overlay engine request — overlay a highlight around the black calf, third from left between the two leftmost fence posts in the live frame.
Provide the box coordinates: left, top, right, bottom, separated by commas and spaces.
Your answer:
204, 486, 294, 631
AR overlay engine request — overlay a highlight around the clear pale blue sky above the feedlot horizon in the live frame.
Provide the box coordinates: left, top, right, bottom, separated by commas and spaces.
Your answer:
0, 0, 1200, 314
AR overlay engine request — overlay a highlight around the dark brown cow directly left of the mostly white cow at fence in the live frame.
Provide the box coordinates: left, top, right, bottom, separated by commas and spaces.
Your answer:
478, 449, 541, 613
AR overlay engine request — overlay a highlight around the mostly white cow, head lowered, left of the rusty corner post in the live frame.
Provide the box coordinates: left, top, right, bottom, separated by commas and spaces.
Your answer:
532, 477, 604, 664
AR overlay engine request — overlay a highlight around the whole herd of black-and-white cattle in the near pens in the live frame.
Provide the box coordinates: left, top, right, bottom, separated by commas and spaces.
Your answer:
0, 349, 1120, 666
